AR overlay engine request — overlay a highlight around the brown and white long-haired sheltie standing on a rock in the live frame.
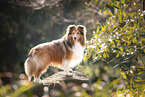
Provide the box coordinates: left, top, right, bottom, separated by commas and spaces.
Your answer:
24, 25, 86, 82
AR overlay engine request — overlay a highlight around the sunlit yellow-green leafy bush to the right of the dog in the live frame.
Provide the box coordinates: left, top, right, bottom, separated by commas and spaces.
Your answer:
85, 0, 145, 96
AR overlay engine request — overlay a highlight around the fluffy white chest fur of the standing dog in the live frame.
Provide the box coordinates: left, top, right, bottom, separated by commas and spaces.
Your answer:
62, 42, 85, 69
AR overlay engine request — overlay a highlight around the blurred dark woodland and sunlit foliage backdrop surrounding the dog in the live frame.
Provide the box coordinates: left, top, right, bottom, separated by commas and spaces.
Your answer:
0, 0, 145, 97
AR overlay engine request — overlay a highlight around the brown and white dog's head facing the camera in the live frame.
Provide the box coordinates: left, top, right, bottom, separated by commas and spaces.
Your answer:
67, 25, 86, 47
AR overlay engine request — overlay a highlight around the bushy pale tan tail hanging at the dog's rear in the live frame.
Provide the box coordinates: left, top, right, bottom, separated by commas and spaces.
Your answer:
24, 56, 36, 81
